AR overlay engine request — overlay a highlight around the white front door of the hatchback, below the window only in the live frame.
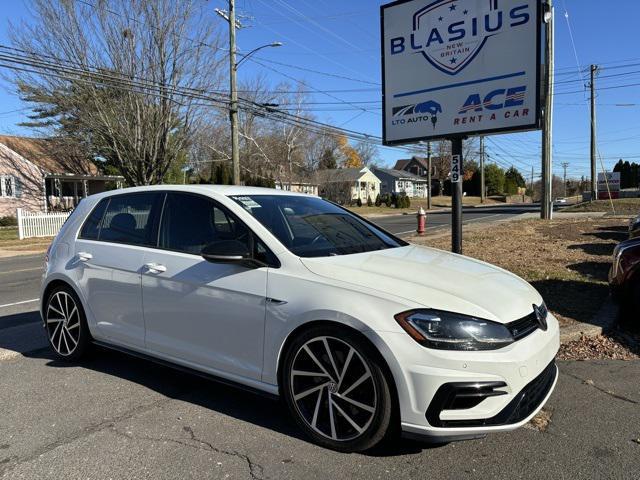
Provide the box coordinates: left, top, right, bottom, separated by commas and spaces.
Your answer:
142, 251, 267, 379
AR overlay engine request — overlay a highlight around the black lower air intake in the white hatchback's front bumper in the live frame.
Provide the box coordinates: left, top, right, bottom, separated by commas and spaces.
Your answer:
426, 360, 558, 428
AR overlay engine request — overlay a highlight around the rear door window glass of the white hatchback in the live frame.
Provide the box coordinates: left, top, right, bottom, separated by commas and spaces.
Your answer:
98, 192, 164, 246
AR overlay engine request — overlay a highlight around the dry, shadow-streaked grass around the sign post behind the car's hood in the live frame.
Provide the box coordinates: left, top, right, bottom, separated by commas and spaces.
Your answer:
410, 218, 627, 325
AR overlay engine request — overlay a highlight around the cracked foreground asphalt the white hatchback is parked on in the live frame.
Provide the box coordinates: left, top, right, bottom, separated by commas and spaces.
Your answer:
0, 311, 640, 480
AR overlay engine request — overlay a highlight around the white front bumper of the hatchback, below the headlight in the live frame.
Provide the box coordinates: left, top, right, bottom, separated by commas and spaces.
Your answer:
364, 314, 560, 441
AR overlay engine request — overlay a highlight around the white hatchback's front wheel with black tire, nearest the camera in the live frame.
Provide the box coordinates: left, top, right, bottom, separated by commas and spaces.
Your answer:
280, 326, 394, 452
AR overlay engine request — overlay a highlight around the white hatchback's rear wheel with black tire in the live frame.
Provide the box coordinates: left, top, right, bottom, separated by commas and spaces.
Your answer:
44, 285, 91, 362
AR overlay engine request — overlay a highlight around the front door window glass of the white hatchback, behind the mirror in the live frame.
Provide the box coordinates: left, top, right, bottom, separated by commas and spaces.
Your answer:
159, 193, 249, 255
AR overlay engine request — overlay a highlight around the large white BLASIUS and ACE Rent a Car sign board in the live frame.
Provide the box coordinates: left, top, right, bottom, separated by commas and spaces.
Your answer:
381, 0, 541, 145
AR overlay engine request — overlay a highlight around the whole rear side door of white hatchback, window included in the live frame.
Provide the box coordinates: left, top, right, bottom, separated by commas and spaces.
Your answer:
72, 192, 164, 347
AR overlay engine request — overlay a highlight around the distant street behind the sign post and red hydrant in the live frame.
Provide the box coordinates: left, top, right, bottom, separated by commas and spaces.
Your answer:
371, 204, 540, 236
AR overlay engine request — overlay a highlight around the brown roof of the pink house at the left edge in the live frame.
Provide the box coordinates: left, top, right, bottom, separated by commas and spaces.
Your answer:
0, 135, 98, 175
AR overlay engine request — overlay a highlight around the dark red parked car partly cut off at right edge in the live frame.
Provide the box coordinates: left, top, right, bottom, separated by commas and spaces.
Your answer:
609, 238, 640, 329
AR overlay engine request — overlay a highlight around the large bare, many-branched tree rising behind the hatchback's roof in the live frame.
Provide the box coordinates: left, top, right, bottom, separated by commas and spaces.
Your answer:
11, 0, 224, 185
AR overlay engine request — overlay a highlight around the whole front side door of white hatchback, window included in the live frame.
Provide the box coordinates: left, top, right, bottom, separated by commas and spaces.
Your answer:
141, 192, 267, 379
